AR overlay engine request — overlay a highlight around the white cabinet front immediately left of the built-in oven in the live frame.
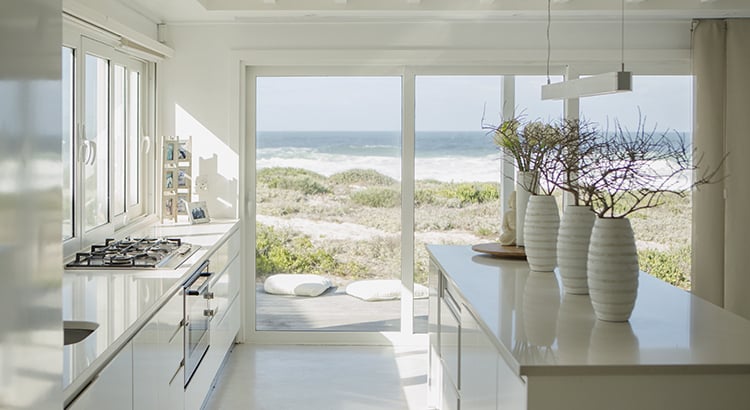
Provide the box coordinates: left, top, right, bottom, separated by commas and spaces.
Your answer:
132, 292, 184, 410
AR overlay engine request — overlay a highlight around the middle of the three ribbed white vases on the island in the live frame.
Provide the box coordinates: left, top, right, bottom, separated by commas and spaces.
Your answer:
557, 206, 596, 295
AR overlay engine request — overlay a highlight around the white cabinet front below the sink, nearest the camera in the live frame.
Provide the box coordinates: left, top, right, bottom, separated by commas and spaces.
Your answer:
67, 343, 133, 410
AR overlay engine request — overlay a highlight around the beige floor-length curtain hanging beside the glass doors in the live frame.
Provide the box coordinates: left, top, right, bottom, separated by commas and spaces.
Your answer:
692, 19, 750, 319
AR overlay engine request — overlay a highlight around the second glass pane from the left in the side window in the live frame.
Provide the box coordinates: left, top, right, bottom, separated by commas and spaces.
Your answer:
82, 54, 110, 231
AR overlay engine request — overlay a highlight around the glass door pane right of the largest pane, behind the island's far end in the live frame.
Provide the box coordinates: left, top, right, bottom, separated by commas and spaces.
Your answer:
414, 75, 503, 333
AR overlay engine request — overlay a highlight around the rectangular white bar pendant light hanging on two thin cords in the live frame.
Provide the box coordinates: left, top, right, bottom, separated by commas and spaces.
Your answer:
542, 0, 633, 100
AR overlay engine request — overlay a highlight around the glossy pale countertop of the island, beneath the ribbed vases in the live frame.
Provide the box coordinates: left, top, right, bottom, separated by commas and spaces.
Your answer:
427, 245, 750, 376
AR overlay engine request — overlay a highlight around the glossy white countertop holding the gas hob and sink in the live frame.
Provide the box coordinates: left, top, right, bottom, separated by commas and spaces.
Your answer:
63, 221, 239, 401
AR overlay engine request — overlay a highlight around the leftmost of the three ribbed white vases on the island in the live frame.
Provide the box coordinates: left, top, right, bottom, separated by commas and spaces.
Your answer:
524, 195, 560, 272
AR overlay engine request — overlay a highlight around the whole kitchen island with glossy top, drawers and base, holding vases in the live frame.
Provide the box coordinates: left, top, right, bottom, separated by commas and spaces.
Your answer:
428, 245, 750, 410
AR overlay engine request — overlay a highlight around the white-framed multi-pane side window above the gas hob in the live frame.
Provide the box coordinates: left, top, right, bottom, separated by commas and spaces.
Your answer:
62, 31, 149, 255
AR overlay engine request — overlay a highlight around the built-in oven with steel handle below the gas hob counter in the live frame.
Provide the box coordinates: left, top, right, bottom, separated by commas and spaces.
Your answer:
183, 261, 214, 387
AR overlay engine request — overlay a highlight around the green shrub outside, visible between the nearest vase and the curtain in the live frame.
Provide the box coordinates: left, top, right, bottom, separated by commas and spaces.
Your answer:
638, 246, 690, 289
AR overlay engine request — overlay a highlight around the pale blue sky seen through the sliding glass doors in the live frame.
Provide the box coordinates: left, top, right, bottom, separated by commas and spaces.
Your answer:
257, 75, 693, 131
